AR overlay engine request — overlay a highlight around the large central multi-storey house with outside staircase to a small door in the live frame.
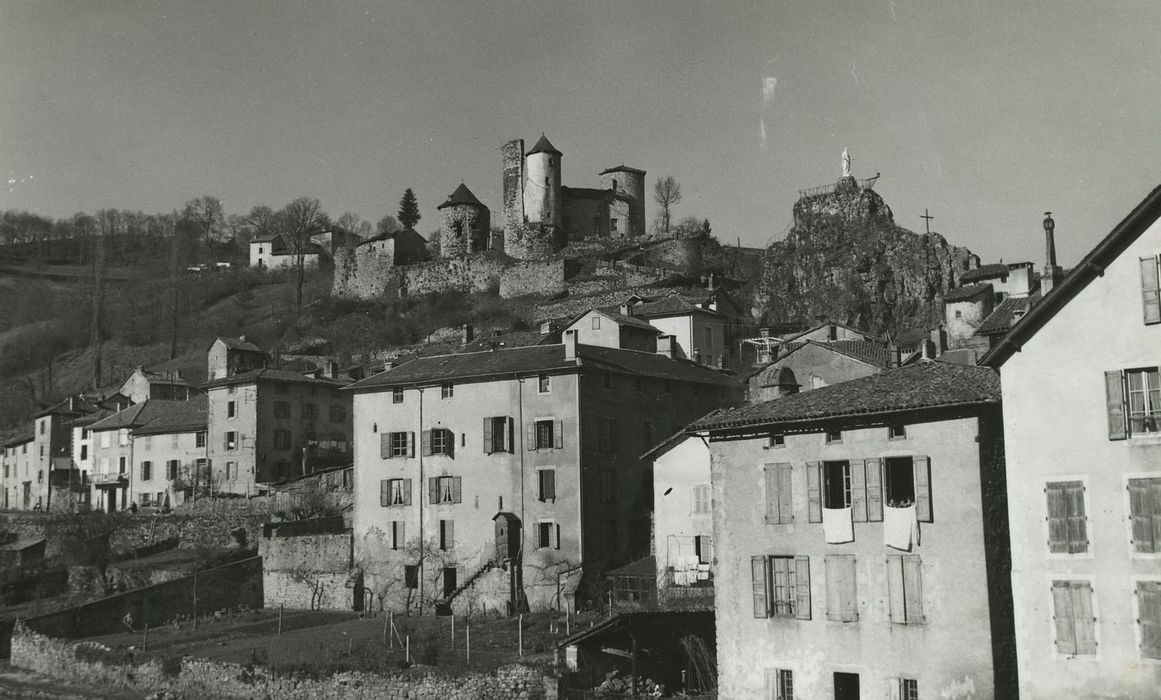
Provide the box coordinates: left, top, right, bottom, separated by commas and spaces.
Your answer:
348, 332, 741, 611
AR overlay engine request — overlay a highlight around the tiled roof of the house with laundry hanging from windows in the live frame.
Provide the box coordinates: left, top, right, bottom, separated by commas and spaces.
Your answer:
688, 360, 1000, 431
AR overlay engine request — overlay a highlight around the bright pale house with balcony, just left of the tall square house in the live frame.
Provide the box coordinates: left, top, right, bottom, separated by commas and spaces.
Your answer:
90, 396, 208, 513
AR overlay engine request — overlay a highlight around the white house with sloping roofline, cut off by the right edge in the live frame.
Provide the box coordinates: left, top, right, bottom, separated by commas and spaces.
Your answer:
981, 188, 1161, 699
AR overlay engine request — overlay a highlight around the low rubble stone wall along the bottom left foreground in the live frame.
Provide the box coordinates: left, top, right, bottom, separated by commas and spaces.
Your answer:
12, 625, 557, 700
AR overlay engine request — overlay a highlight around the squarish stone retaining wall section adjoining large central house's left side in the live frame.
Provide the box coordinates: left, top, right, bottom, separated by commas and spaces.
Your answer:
258, 533, 354, 611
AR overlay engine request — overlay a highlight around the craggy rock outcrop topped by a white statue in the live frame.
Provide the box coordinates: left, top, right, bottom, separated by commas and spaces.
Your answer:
753, 178, 978, 333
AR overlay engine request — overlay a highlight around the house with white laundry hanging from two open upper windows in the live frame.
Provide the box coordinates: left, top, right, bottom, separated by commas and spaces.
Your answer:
687, 359, 1015, 700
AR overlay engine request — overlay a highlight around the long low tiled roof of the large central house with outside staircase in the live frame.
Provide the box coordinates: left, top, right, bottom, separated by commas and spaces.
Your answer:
348, 341, 741, 390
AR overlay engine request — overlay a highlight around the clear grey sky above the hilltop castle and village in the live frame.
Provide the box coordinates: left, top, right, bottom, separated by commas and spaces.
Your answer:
0, 0, 1161, 265
